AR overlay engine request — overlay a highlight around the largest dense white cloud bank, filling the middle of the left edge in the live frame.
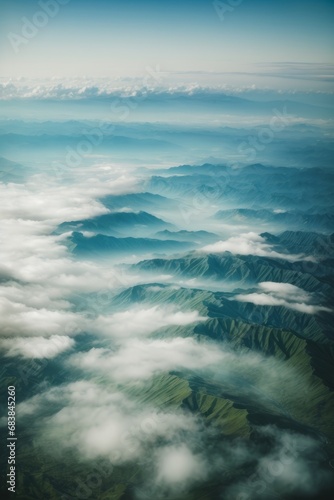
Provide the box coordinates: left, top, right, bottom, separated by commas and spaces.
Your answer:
0, 171, 141, 357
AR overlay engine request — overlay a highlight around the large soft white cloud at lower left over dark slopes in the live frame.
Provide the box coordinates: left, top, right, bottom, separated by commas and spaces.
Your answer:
17, 381, 201, 464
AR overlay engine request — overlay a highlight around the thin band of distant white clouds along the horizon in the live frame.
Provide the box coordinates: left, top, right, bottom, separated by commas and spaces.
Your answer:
0, 74, 334, 100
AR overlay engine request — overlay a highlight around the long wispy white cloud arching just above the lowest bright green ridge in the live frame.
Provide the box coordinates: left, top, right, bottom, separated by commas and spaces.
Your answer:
66, 328, 313, 407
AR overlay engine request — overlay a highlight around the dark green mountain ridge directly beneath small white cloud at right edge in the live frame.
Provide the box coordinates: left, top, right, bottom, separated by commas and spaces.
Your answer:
113, 284, 334, 344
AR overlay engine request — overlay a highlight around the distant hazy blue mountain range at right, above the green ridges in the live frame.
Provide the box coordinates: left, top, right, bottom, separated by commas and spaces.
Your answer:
146, 164, 334, 214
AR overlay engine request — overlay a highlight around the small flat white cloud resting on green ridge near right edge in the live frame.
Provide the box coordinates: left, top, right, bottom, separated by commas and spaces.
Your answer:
233, 281, 331, 314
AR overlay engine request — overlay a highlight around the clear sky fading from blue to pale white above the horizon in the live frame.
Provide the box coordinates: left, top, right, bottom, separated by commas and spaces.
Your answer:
0, 0, 334, 90
